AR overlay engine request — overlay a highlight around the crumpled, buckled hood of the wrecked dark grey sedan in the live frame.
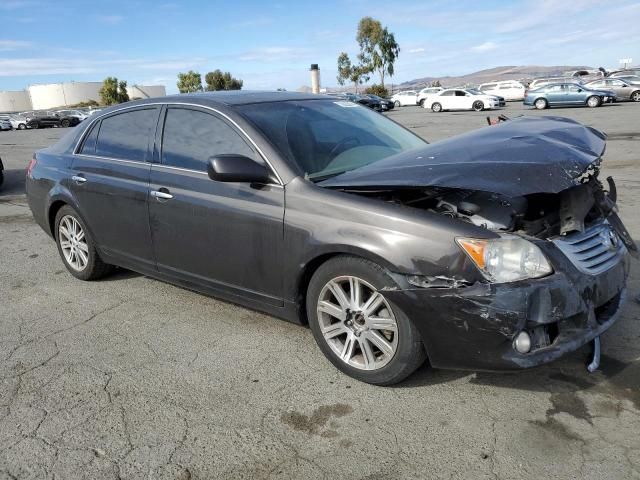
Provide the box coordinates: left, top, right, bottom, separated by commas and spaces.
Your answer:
319, 117, 606, 197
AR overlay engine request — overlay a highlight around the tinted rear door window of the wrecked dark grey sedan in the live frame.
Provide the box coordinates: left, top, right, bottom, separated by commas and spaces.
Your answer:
92, 107, 158, 162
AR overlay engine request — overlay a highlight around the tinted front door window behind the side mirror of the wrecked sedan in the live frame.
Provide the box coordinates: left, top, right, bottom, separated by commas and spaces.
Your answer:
162, 107, 262, 172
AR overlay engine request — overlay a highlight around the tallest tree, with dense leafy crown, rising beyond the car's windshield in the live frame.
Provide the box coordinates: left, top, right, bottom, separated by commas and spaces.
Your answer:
356, 17, 400, 88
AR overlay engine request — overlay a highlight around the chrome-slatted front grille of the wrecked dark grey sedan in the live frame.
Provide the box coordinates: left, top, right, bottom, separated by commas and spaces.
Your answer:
553, 221, 625, 275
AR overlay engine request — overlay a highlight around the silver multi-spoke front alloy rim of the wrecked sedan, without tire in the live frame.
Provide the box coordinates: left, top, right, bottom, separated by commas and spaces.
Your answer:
317, 276, 398, 370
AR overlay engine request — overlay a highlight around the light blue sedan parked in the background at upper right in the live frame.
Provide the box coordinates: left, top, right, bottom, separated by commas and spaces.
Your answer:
524, 83, 616, 110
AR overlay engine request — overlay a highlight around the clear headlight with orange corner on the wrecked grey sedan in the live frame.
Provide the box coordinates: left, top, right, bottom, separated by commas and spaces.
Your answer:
456, 235, 553, 283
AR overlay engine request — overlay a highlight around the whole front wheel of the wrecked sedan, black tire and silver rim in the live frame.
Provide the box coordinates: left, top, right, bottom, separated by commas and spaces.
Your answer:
307, 255, 426, 385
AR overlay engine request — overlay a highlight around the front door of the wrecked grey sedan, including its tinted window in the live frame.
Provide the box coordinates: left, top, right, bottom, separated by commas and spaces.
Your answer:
149, 105, 284, 306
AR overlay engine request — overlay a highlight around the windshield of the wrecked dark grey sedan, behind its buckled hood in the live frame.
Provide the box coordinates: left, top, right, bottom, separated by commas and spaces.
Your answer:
238, 100, 427, 181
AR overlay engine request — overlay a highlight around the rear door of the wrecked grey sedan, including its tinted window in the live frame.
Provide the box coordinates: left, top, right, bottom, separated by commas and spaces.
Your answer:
70, 106, 160, 270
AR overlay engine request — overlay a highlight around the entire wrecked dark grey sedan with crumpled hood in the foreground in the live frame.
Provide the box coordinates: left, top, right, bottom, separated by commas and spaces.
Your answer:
26, 92, 637, 385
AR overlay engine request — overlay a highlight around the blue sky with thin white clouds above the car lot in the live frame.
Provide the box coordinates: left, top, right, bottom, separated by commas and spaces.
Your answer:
0, 0, 640, 92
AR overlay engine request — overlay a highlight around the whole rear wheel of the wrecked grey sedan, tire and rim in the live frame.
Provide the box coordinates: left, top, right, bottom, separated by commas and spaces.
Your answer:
54, 205, 113, 280
